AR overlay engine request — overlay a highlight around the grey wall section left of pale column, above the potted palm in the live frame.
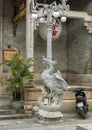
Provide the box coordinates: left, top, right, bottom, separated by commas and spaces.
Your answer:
3, 0, 26, 56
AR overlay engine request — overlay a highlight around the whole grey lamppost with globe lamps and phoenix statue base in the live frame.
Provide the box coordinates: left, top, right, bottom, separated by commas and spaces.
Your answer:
31, 2, 68, 119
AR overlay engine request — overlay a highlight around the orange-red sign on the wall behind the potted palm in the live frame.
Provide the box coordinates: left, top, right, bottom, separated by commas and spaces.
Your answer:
3, 50, 16, 61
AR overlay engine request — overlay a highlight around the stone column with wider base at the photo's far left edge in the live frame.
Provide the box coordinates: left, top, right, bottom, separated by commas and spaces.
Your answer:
0, 0, 11, 109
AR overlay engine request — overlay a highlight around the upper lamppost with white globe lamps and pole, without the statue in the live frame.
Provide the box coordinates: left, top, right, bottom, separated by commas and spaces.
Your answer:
31, 2, 66, 59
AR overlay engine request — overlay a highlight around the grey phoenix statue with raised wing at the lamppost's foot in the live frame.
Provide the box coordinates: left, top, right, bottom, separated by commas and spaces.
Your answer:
38, 58, 68, 111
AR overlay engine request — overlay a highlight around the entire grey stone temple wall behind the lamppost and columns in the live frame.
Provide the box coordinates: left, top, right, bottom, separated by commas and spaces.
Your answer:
3, 0, 92, 84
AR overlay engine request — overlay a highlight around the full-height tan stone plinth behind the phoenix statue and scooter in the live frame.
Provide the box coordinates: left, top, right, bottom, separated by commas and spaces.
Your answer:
25, 84, 92, 112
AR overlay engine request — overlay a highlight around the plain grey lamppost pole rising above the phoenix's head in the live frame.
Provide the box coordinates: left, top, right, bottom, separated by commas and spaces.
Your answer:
47, 8, 52, 59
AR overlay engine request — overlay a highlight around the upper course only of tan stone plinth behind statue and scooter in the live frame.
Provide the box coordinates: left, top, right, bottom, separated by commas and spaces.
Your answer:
25, 85, 92, 101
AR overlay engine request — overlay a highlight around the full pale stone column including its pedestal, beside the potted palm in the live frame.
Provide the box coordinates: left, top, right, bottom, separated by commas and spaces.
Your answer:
24, 0, 34, 117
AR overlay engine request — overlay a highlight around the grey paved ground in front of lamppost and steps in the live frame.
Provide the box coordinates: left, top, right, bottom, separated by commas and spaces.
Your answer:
0, 112, 92, 130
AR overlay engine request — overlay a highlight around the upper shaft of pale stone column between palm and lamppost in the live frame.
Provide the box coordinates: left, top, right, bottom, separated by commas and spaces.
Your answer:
26, 0, 34, 66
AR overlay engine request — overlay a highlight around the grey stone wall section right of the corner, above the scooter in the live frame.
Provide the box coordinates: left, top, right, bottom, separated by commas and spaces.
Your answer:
67, 0, 92, 84
